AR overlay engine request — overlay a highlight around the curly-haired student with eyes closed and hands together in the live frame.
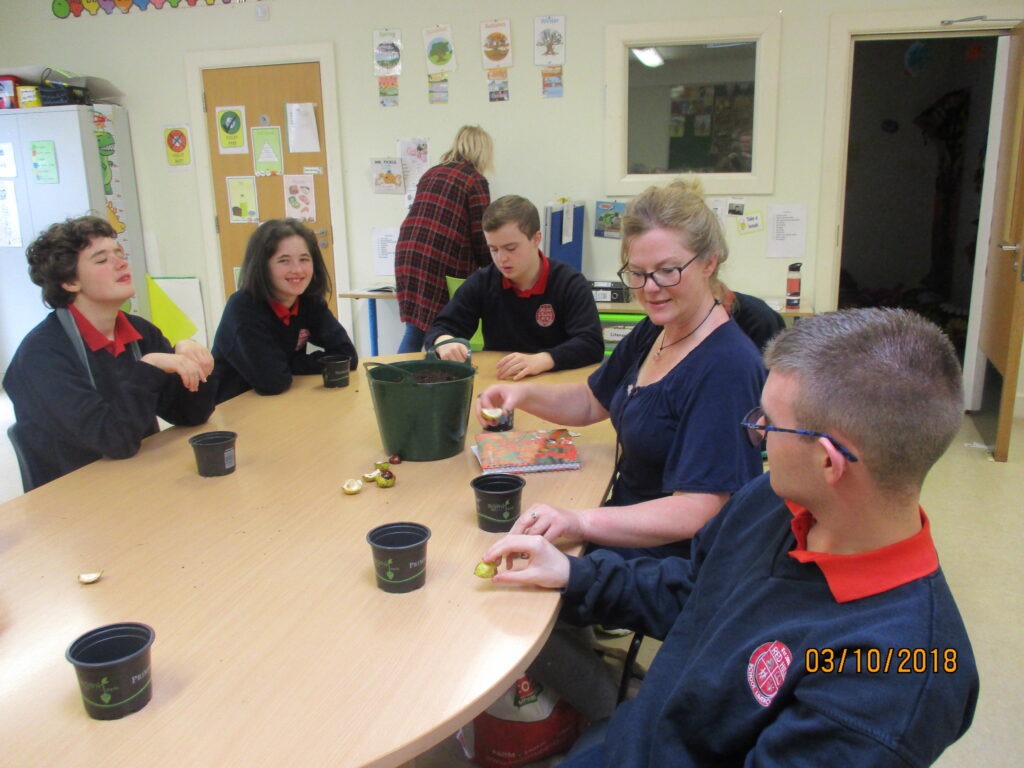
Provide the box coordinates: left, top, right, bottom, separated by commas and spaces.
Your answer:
3, 216, 215, 490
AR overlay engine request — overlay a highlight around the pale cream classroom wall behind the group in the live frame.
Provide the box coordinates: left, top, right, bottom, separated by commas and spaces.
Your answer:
0, 0, 1019, 409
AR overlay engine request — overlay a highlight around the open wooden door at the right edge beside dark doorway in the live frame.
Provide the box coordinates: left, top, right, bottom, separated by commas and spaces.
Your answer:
981, 25, 1024, 462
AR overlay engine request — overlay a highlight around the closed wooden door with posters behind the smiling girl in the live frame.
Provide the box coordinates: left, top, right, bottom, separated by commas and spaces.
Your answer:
203, 61, 338, 314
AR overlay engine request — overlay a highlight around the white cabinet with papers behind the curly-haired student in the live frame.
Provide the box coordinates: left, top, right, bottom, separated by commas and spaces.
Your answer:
0, 104, 150, 375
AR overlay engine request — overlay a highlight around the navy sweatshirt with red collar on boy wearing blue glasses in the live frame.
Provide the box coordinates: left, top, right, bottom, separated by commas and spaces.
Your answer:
562, 475, 978, 768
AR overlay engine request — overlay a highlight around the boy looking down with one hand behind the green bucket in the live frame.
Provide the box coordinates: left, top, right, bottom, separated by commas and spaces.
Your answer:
425, 195, 604, 381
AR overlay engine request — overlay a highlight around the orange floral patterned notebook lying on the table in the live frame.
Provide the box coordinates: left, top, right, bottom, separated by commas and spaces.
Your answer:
473, 429, 580, 475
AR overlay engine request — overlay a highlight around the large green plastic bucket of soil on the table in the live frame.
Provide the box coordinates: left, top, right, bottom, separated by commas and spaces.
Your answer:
362, 359, 476, 462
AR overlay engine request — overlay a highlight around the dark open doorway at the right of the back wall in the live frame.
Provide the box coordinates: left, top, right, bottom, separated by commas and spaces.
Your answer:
839, 36, 996, 357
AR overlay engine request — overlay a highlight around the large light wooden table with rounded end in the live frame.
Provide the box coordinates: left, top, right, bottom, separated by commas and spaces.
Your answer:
0, 353, 613, 768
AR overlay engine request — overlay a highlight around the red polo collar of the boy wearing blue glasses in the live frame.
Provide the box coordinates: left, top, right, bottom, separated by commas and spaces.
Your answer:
785, 501, 939, 603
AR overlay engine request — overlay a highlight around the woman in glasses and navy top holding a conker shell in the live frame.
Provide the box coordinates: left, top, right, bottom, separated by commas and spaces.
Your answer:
477, 180, 765, 557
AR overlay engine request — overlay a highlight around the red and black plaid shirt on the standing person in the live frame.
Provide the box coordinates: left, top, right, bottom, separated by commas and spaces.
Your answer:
394, 163, 490, 331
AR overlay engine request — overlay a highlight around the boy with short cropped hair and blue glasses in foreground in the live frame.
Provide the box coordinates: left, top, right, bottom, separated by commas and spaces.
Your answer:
484, 309, 978, 768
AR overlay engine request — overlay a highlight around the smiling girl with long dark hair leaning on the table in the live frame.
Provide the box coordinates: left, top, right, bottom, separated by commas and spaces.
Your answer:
213, 219, 358, 402
